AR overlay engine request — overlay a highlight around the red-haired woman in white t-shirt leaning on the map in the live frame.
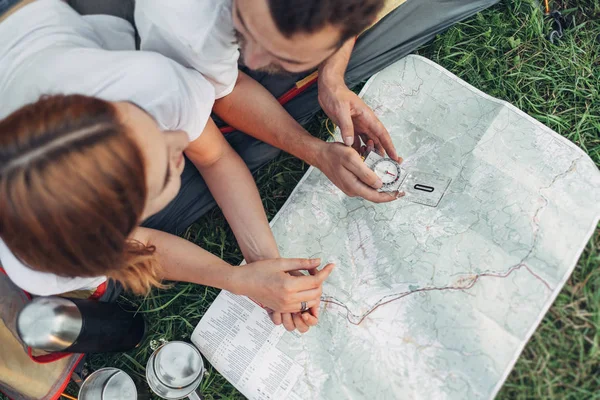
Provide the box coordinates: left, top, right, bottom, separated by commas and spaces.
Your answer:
0, 0, 331, 331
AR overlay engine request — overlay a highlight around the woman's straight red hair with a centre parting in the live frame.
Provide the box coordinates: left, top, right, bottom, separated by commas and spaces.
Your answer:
0, 95, 160, 293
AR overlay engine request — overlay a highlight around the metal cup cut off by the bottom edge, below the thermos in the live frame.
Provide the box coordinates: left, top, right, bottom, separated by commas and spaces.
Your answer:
78, 368, 137, 400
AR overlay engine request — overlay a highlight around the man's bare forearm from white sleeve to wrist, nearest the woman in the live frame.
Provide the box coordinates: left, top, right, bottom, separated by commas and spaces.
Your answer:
213, 72, 323, 165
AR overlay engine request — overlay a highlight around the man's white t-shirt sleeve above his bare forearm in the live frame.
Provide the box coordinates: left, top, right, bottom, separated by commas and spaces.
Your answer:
135, 0, 240, 99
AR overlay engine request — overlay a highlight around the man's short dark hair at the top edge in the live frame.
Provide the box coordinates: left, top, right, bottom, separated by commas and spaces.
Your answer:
269, 0, 384, 42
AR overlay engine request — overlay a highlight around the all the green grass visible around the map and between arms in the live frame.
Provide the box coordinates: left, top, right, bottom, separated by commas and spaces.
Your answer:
41, 0, 600, 399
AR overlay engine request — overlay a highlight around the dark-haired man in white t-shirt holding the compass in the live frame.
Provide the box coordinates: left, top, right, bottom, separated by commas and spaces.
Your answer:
135, 0, 398, 209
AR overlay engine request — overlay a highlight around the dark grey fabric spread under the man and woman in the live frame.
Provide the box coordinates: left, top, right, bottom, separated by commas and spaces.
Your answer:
69, 0, 498, 233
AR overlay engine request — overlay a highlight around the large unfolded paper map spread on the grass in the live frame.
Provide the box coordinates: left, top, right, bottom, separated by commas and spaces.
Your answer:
192, 56, 600, 400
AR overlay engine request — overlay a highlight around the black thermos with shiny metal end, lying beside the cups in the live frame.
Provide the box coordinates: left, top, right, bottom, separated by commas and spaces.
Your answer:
17, 297, 146, 353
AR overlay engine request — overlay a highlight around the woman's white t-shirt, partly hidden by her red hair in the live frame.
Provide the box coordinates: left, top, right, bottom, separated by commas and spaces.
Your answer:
0, 0, 214, 295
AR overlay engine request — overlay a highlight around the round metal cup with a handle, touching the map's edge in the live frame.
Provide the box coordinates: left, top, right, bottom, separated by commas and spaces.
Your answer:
146, 341, 205, 400
